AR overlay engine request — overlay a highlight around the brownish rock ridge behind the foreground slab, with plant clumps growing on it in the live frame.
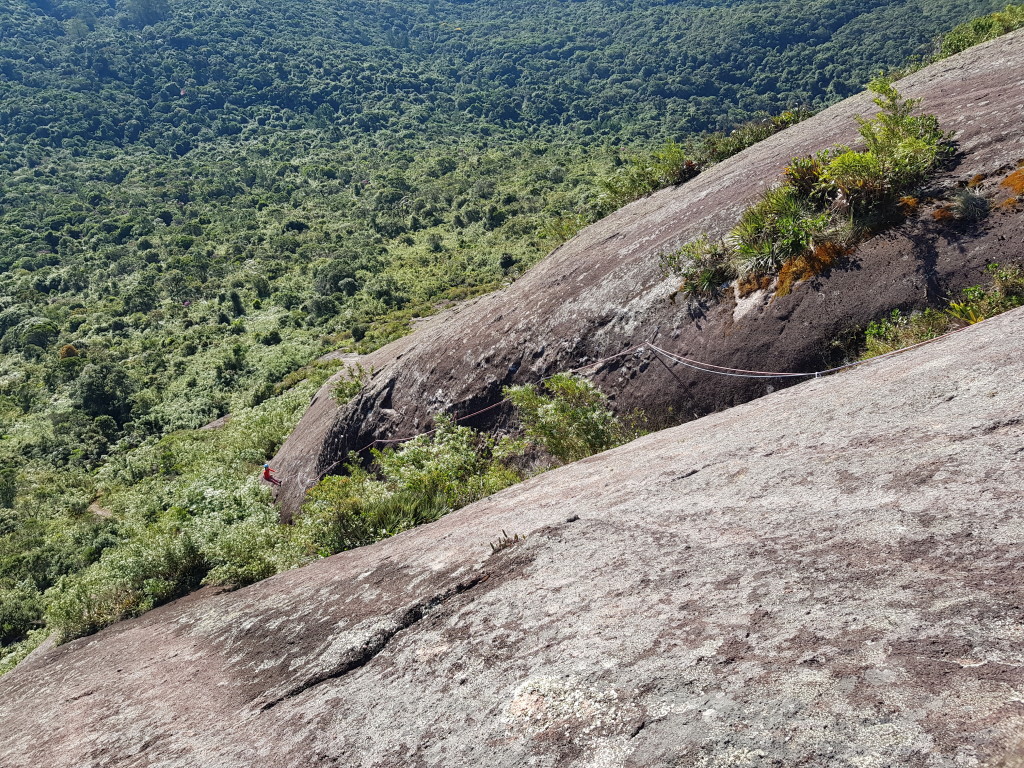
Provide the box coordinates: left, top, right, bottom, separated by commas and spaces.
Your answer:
275, 33, 1024, 518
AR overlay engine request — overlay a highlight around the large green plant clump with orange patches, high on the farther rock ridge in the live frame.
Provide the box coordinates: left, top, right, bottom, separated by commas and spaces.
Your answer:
662, 80, 951, 299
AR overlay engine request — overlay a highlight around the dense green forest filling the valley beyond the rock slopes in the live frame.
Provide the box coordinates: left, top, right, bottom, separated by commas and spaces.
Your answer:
0, 0, 1001, 670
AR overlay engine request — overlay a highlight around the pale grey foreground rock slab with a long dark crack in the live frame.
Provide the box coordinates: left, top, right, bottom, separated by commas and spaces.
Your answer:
0, 310, 1024, 768
